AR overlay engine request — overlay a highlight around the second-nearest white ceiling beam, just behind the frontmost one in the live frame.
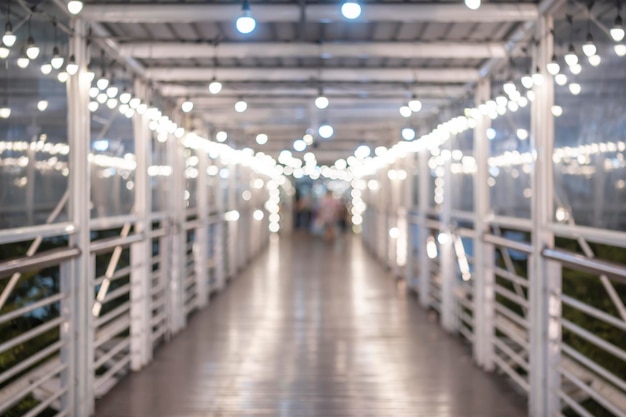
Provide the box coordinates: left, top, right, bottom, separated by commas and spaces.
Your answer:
119, 42, 506, 59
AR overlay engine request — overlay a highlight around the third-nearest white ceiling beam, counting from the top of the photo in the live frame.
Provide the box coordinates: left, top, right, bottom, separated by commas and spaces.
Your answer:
146, 67, 479, 84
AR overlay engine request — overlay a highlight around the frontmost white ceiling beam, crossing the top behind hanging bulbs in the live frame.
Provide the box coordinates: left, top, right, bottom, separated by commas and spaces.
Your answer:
81, 2, 538, 23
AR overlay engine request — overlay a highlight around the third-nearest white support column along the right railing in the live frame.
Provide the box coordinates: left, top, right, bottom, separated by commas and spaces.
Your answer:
439, 133, 459, 332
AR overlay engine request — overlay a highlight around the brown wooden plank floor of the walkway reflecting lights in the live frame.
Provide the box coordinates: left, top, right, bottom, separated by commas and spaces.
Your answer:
97, 236, 526, 417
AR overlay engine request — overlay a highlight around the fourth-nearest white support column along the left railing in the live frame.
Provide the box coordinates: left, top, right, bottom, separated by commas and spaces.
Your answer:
194, 145, 209, 308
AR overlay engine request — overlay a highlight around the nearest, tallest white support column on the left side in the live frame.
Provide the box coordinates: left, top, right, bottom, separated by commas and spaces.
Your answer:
61, 18, 94, 417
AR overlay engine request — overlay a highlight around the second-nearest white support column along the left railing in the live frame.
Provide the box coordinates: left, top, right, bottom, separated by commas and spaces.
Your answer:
130, 83, 152, 371
